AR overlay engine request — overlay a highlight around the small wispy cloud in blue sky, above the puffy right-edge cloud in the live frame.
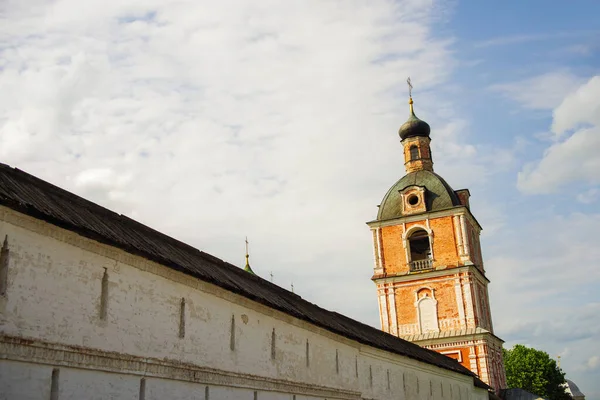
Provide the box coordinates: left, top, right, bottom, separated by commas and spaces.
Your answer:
490, 71, 583, 110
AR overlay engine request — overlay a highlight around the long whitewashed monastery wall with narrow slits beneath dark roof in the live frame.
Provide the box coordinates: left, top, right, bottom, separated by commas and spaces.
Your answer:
0, 206, 488, 400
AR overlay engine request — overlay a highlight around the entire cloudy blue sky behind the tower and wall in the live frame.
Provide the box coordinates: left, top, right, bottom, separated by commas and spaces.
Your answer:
0, 0, 600, 400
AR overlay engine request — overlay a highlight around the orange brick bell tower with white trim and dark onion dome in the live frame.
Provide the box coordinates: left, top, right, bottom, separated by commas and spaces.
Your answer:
368, 78, 506, 392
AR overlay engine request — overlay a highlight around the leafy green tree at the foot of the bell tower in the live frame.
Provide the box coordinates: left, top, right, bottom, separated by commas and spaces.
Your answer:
503, 344, 571, 400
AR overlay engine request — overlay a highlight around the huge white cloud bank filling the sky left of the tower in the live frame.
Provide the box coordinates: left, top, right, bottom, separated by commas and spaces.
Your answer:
0, 0, 478, 324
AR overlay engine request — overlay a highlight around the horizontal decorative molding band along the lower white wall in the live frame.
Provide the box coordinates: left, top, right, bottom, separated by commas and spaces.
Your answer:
0, 335, 361, 400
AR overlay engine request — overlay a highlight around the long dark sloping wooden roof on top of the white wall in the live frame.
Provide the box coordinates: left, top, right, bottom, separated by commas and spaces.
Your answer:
0, 164, 488, 388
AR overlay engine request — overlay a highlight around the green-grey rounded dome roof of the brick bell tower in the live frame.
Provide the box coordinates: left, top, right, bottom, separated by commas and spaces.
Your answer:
377, 170, 461, 220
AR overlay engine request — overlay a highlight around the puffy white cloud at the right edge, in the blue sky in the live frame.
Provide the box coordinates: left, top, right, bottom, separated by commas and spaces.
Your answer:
517, 76, 600, 193
